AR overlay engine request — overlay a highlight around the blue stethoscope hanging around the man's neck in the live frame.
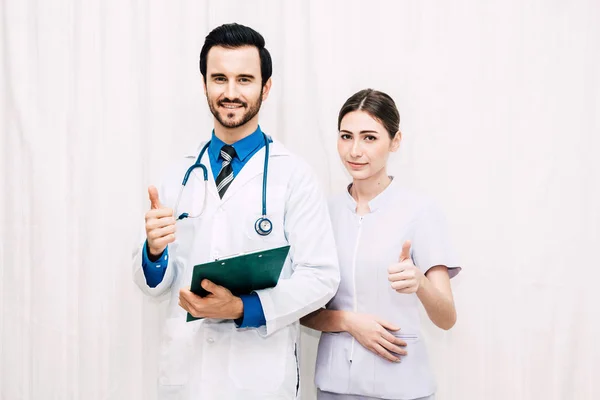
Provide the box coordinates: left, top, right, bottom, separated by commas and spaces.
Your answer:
174, 133, 273, 236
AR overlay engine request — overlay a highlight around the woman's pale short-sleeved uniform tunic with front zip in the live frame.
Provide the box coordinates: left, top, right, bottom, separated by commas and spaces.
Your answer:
315, 180, 460, 400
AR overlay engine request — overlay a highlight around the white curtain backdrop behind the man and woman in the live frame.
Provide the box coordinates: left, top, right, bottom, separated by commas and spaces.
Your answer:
0, 0, 600, 400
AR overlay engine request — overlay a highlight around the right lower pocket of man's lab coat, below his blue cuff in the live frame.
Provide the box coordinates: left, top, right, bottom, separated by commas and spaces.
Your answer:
229, 329, 293, 393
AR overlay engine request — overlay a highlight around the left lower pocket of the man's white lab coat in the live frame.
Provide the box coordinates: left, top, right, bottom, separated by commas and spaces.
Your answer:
159, 318, 192, 386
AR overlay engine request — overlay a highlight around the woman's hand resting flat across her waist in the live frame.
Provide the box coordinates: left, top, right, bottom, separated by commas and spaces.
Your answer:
344, 312, 407, 362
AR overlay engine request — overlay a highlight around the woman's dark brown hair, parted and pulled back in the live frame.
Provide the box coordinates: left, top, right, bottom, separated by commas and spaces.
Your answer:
338, 89, 400, 139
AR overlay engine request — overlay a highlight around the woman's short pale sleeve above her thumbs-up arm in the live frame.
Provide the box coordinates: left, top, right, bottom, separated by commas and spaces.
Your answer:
412, 203, 462, 278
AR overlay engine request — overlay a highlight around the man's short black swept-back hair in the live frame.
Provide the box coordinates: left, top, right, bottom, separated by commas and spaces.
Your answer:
200, 23, 273, 86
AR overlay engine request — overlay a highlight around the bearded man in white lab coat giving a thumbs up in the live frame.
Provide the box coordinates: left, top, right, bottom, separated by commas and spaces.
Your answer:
133, 24, 339, 400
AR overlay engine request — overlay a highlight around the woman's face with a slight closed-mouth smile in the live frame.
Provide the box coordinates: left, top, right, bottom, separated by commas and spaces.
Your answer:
337, 111, 401, 180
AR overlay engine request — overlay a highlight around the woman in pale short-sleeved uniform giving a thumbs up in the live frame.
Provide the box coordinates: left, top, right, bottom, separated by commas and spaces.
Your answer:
302, 89, 460, 400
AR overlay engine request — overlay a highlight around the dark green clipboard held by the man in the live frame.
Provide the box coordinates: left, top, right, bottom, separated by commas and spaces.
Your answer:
187, 245, 290, 322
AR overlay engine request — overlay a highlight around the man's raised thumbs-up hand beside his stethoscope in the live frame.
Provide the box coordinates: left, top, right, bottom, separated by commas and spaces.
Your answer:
146, 186, 175, 257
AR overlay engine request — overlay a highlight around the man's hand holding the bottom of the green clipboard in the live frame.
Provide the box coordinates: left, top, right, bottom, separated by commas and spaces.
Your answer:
179, 279, 244, 319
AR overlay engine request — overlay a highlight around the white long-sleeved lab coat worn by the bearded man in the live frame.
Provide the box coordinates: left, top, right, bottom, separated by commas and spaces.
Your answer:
133, 142, 339, 400
